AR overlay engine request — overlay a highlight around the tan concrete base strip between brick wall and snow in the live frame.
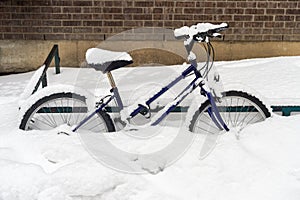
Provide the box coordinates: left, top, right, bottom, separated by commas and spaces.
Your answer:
0, 40, 300, 74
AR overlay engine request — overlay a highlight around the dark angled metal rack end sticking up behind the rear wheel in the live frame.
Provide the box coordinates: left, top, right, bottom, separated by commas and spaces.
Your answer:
32, 44, 60, 94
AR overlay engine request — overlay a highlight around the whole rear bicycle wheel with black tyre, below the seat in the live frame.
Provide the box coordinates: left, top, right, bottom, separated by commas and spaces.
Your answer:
19, 92, 115, 132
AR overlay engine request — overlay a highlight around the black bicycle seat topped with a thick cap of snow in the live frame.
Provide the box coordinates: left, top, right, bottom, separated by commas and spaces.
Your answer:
85, 48, 133, 73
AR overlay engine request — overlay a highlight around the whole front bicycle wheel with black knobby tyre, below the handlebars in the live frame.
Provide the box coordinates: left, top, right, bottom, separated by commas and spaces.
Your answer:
189, 91, 271, 134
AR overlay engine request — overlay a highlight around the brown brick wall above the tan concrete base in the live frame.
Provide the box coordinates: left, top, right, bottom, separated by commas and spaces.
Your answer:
0, 0, 300, 41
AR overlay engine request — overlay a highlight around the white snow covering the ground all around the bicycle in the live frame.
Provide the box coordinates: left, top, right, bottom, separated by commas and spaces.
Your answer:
0, 57, 300, 200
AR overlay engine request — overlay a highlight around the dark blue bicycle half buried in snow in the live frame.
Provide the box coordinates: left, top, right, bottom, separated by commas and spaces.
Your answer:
19, 23, 270, 136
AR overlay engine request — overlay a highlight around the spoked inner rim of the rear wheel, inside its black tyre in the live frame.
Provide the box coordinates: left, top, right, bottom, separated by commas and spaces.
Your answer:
25, 97, 107, 132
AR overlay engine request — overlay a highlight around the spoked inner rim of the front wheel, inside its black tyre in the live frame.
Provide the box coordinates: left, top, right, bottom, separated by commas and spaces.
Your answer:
192, 96, 266, 134
